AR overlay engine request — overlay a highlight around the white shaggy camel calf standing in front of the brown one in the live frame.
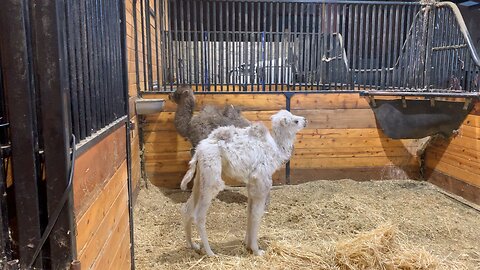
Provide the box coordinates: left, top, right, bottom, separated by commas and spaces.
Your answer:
181, 110, 306, 256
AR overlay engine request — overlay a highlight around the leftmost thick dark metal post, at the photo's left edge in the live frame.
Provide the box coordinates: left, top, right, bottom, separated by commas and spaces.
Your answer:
0, 0, 43, 268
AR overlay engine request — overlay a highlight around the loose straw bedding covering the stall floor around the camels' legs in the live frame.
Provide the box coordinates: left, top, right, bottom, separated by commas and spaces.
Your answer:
134, 180, 480, 270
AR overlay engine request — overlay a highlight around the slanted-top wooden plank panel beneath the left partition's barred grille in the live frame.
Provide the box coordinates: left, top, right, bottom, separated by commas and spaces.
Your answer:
73, 126, 130, 269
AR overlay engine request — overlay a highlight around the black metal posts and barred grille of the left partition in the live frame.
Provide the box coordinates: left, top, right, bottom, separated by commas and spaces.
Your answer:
0, 0, 130, 269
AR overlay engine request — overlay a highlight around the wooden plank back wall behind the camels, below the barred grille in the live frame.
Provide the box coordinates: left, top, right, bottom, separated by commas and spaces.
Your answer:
143, 93, 419, 188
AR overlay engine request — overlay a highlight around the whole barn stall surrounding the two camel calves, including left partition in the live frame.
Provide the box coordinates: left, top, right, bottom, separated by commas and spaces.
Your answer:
0, 0, 480, 269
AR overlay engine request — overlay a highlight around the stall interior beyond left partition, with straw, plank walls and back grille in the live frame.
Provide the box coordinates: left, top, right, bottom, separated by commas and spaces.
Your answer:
133, 1, 480, 269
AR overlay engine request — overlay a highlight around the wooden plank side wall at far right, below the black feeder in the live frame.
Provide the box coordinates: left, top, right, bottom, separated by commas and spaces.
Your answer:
425, 102, 480, 204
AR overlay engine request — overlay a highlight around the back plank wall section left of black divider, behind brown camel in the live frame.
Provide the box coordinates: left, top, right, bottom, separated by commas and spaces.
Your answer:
143, 94, 286, 188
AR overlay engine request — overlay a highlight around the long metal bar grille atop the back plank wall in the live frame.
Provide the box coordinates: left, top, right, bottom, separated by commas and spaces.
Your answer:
136, 0, 480, 92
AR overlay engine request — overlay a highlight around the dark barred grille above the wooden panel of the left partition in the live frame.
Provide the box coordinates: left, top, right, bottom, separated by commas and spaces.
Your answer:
65, 0, 125, 140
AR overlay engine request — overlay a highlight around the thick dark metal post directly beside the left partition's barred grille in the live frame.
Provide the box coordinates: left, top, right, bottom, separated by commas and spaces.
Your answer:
34, 1, 76, 269
